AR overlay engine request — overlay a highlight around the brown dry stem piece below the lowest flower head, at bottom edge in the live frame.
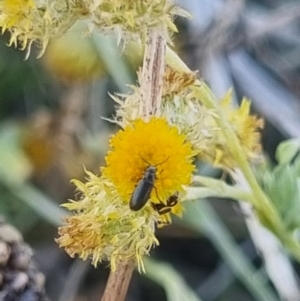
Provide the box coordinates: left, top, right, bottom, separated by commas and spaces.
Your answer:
101, 261, 135, 301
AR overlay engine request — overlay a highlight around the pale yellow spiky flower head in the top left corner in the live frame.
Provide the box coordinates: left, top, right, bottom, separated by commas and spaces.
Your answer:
0, 0, 78, 56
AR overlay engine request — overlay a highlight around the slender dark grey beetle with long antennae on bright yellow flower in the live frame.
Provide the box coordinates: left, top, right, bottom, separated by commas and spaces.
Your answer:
129, 157, 169, 211
